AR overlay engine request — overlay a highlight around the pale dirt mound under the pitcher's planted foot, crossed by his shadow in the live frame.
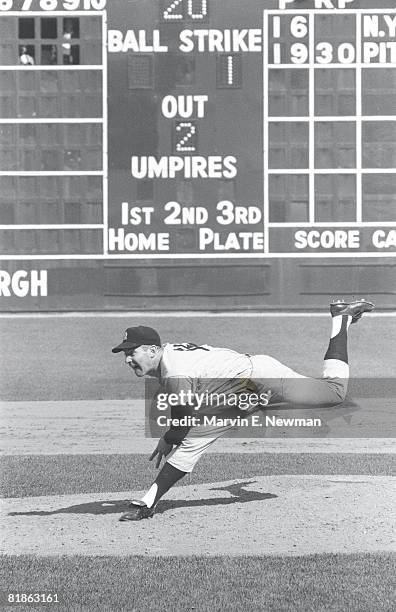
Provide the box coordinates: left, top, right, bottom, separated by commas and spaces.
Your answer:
1, 475, 396, 556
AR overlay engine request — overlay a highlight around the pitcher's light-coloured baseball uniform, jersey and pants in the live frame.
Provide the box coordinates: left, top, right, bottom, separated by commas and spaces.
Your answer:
156, 343, 349, 472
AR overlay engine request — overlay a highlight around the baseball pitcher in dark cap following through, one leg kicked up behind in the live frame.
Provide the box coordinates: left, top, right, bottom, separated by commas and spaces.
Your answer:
112, 300, 374, 521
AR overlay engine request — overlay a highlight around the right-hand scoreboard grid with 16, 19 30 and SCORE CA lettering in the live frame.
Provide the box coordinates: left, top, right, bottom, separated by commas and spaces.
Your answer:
264, 9, 396, 256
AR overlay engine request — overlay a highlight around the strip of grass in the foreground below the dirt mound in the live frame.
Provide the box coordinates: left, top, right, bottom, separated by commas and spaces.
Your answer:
2, 554, 395, 612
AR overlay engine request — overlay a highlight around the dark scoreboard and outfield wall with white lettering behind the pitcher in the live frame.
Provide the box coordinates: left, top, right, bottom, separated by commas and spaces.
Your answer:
0, 0, 396, 311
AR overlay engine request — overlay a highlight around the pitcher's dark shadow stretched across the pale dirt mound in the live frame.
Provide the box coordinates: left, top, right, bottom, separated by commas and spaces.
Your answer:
8, 481, 278, 516
